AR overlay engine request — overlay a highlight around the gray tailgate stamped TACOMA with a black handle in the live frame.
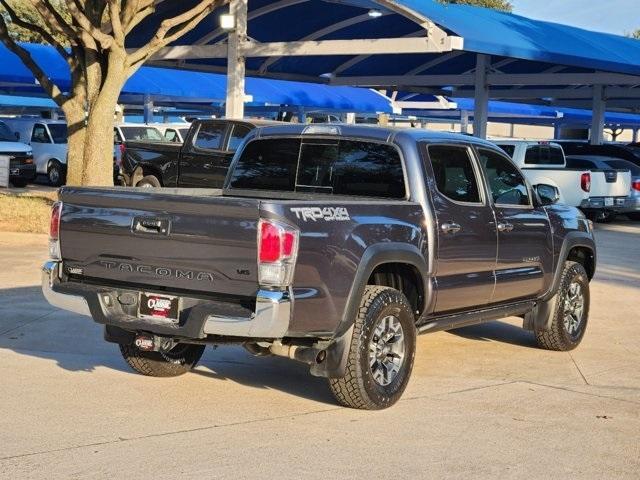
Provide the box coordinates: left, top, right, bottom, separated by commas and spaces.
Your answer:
60, 187, 260, 296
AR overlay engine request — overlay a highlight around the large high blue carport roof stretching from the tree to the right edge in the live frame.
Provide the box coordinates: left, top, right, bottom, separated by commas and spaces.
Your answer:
130, 0, 640, 77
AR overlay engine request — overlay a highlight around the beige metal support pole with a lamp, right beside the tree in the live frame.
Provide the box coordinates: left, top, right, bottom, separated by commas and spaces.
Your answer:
225, 0, 248, 119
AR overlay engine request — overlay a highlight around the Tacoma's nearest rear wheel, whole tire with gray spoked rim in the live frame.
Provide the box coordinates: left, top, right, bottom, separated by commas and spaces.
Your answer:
329, 285, 416, 410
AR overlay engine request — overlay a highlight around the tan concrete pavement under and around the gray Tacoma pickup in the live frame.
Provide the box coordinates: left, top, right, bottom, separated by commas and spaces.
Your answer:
0, 223, 640, 479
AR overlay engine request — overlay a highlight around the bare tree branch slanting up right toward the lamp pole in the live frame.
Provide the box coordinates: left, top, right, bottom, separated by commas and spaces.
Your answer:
129, 0, 223, 67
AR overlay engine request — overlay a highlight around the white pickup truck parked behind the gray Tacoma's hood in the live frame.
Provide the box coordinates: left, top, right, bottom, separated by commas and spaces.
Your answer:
493, 140, 631, 218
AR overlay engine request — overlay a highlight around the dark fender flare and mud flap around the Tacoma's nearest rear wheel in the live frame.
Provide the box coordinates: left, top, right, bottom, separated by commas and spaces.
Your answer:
311, 242, 432, 378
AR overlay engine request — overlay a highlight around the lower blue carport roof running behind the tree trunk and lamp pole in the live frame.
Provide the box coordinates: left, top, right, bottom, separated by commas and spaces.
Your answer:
0, 44, 392, 113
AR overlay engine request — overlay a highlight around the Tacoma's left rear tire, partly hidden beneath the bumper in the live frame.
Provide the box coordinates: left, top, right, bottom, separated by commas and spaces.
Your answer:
120, 343, 205, 377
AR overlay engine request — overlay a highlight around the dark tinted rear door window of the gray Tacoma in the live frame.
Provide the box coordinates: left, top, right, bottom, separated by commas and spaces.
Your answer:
427, 145, 481, 203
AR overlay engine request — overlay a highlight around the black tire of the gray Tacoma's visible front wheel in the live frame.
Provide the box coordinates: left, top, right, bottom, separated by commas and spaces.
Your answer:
535, 262, 589, 352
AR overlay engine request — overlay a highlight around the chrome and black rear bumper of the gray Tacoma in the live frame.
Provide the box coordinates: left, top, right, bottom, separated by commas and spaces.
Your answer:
42, 261, 293, 339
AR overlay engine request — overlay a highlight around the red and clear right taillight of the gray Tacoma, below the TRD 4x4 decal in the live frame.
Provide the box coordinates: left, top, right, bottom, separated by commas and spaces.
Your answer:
258, 220, 299, 287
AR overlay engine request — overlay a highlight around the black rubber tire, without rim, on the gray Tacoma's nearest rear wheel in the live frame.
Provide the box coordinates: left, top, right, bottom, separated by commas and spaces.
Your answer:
329, 285, 416, 410
